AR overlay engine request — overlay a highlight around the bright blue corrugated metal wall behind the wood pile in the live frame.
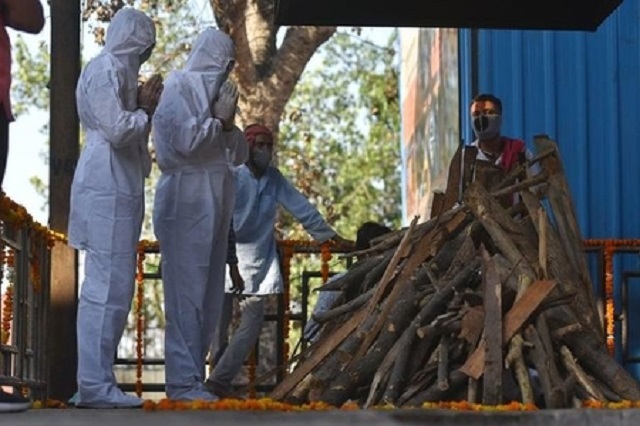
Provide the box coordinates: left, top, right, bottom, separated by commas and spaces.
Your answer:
460, 0, 640, 377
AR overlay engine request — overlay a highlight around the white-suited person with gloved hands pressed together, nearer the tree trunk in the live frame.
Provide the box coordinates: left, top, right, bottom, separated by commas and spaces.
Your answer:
153, 28, 248, 400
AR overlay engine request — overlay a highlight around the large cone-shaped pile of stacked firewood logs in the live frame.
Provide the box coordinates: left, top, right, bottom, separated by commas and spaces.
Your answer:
270, 137, 640, 408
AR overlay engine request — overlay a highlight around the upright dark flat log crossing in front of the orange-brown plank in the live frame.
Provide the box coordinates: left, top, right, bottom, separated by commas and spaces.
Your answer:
480, 246, 503, 405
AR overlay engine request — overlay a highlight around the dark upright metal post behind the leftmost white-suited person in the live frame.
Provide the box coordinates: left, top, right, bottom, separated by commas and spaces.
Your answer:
47, 0, 81, 400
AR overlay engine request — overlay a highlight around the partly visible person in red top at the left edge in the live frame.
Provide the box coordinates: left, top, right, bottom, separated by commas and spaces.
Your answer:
0, 0, 44, 191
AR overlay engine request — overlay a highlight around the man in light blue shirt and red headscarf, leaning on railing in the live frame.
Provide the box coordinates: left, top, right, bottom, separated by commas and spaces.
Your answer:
205, 124, 346, 397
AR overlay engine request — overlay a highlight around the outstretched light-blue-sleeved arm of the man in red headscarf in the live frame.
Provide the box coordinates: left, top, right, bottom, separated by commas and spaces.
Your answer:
273, 169, 338, 243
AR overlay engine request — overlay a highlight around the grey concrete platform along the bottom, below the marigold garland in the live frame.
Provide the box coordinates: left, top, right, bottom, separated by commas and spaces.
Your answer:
0, 408, 640, 426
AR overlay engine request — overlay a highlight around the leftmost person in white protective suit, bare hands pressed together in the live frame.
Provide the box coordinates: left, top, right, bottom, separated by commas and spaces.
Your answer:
69, 8, 162, 408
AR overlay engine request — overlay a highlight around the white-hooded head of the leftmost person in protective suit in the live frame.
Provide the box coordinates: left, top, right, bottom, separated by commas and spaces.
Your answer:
104, 7, 156, 68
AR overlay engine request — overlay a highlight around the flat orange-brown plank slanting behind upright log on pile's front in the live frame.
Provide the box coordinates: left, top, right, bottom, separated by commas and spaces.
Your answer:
460, 280, 556, 380
